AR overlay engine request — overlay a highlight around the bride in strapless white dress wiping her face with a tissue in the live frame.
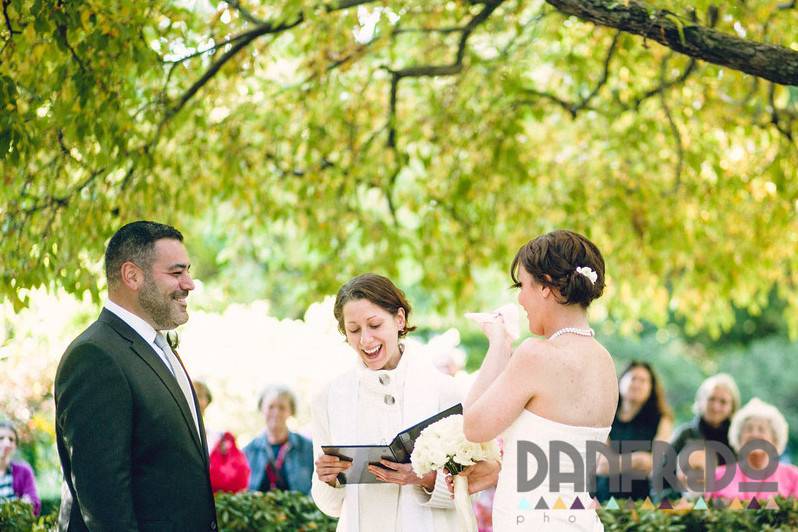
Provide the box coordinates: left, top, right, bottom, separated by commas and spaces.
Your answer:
464, 230, 618, 532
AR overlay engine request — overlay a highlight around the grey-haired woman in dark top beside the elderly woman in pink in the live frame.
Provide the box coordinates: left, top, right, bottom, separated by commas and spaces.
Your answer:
659, 373, 740, 498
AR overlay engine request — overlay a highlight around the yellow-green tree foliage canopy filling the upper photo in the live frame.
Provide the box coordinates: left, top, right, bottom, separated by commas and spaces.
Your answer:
0, 0, 798, 335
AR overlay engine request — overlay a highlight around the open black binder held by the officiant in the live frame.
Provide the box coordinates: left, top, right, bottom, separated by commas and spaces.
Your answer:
321, 403, 463, 484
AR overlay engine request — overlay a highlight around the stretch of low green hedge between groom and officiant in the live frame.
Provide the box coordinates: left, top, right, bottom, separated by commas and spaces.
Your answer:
216, 491, 336, 532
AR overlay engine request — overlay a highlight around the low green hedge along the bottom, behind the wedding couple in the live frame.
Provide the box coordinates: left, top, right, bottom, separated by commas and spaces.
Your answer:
0, 491, 798, 532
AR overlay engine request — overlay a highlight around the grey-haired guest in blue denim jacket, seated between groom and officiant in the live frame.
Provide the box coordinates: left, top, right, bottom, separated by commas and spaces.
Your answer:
244, 386, 313, 495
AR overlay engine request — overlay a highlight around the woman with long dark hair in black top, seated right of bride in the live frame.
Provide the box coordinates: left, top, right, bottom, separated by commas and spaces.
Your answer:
596, 361, 673, 501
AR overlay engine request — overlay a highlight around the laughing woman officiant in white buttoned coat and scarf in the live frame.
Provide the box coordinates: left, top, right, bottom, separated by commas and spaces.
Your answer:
311, 274, 459, 532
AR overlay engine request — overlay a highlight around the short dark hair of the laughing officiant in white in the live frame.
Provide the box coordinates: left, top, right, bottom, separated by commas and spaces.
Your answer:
333, 273, 416, 338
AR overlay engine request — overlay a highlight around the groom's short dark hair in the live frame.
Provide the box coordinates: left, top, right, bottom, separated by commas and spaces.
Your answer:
105, 220, 183, 286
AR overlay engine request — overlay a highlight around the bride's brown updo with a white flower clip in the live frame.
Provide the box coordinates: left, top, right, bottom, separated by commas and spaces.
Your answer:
510, 230, 604, 308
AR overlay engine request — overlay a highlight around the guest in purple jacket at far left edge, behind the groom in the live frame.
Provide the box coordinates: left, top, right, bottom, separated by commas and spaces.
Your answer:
0, 421, 42, 515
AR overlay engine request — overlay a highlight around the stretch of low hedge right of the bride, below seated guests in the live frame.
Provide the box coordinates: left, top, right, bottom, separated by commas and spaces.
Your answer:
598, 497, 798, 532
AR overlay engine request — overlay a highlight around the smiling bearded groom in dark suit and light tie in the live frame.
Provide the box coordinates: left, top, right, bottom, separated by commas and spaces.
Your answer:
55, 221, 216, 532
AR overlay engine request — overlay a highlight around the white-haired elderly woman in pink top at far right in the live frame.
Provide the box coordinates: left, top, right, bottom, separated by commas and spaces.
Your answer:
708, 397, 798, 500
